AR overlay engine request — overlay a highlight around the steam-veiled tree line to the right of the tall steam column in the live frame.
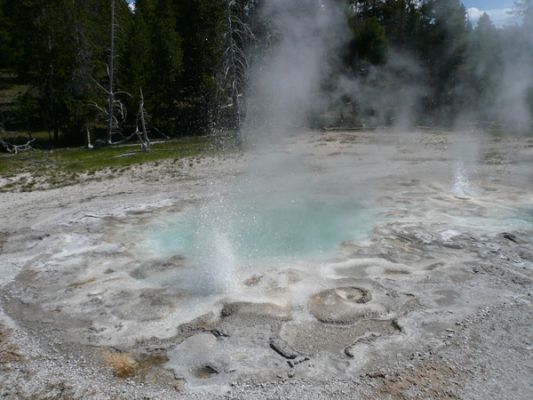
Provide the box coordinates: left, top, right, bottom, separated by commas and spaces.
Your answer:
336, 0, 533, 129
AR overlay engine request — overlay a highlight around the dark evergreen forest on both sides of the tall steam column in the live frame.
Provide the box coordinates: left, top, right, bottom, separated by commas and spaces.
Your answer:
0, 0, 533, 145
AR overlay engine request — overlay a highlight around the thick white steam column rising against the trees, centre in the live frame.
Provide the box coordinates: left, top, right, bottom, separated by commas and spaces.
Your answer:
243, 0, 348, 141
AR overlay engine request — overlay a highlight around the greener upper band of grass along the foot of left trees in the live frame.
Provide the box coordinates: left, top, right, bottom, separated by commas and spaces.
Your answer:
0, 137, 214, 177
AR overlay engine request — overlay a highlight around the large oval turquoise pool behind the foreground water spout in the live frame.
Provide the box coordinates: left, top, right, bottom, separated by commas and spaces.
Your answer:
148, 196, 376, 266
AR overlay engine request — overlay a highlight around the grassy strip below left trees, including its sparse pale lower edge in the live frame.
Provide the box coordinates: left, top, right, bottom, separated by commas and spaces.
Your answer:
0, 137, 219, 191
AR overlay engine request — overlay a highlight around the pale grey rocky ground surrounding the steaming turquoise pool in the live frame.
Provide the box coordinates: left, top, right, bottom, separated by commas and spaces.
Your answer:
0, 132, 533, 399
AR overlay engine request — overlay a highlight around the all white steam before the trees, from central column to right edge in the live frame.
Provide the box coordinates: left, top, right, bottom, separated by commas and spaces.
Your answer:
242, 0, 533, 136
